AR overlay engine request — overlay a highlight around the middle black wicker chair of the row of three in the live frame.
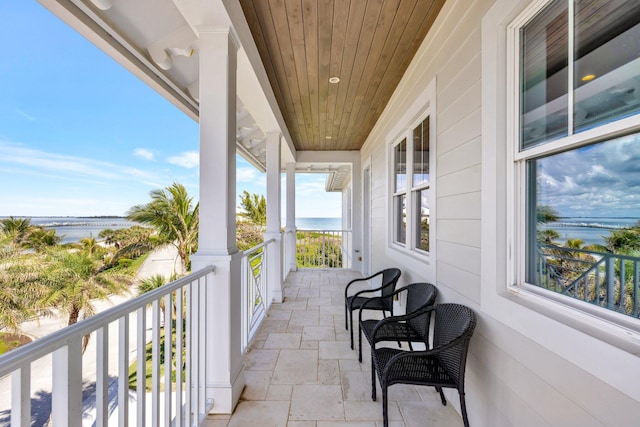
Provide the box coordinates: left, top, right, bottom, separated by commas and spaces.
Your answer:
358, 283, 438, 362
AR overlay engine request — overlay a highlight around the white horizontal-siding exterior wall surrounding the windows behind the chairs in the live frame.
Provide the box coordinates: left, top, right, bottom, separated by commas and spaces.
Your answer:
354, 0, 640, 427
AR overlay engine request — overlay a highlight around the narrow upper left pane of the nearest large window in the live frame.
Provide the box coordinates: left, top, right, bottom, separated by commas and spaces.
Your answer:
520, 0, 568, 148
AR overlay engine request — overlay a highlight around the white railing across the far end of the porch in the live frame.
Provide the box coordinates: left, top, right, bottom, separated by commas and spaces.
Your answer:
296, 230, 353, 268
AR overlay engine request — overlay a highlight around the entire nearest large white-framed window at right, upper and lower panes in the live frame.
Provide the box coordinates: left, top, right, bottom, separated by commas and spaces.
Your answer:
509, 0, 640, 318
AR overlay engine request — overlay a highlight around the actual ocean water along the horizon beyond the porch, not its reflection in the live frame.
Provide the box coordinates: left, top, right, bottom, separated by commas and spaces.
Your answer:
0, 216, 342, 243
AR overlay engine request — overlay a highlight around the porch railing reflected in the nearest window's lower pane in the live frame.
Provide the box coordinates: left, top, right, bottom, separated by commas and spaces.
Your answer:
536, 245, 640, 317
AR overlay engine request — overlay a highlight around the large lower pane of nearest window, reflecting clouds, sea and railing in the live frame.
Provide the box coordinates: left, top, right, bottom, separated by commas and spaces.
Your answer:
526, 134, 640, 317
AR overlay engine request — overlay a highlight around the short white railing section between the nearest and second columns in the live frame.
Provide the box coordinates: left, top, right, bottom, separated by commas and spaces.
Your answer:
242, 239, 275, 351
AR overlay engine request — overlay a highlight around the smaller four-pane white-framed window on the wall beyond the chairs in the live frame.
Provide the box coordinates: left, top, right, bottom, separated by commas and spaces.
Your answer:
391, 115, 431, 254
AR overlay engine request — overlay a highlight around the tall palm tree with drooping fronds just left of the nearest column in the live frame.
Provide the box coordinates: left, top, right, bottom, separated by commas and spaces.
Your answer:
127, 182, 199, 272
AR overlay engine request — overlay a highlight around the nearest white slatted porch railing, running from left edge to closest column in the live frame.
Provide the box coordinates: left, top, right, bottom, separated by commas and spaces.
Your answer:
0, 267, 214, 427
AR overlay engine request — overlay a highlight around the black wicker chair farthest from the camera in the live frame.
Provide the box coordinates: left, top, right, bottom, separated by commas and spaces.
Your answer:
344, 268, 401, 348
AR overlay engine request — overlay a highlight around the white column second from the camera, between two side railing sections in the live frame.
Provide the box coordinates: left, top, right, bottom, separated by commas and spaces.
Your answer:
264, 132, 282, 305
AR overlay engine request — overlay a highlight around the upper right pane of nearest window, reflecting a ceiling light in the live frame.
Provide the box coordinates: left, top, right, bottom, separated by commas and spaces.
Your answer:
574, 0, 640, 132
